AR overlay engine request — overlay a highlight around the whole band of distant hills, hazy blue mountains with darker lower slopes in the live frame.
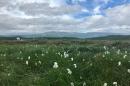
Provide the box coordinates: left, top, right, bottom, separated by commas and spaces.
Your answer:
0, 32, 126, 40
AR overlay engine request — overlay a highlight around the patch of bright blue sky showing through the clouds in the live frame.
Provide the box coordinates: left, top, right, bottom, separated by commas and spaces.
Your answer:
71, 0, 130, 18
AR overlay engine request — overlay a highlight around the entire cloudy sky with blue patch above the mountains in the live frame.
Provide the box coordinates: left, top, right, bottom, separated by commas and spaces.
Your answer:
0, 0, 130, 35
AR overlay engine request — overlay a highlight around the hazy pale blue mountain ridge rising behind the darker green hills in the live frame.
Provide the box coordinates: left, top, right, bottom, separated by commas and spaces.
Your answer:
20, 32, 120, 38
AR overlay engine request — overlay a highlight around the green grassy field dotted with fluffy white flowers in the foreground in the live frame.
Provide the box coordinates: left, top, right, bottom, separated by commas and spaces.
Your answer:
0, 42, 130, 86
